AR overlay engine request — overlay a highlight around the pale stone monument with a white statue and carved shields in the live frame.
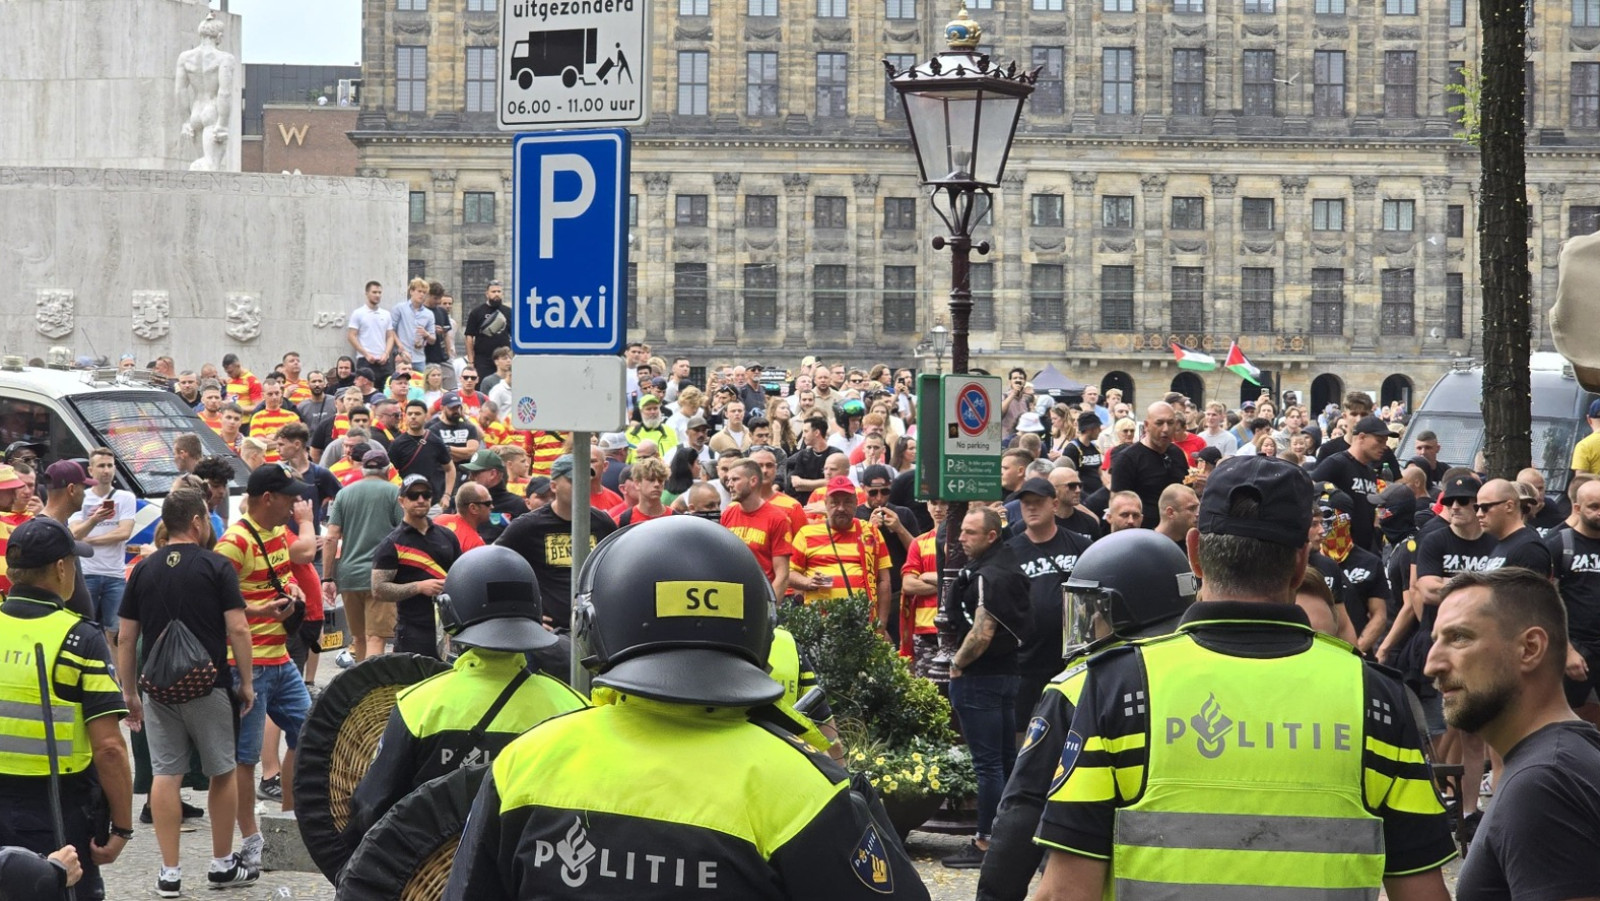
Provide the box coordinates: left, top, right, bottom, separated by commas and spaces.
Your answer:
0, 0, 410, 371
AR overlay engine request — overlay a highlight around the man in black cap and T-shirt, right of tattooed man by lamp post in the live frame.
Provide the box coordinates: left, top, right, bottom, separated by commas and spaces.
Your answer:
1006, 480, 1093, 731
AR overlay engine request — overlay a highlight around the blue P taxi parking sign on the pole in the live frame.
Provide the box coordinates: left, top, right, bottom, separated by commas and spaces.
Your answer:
510, 128, 629, 355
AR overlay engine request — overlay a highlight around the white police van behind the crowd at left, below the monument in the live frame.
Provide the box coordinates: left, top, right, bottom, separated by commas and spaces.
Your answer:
0, 357, 250, 544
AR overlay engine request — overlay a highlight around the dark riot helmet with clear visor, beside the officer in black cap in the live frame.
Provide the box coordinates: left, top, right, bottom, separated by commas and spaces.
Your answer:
1062, 528, 1195, 656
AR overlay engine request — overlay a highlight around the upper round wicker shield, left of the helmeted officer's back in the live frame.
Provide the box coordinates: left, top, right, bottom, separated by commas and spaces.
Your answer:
294, 655, 450, 882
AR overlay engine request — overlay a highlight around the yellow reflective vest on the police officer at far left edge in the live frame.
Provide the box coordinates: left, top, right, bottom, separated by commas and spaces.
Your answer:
0, 610, 94, 776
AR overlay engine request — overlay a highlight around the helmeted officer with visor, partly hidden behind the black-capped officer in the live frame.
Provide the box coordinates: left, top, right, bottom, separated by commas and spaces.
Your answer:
978, 528, 1195, 901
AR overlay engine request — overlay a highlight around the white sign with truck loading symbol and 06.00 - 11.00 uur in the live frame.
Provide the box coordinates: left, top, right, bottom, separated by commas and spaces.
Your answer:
496, 0, 650, 131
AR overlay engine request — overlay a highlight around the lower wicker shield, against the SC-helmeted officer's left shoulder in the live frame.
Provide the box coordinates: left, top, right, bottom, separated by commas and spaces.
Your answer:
334, 767, 490, 901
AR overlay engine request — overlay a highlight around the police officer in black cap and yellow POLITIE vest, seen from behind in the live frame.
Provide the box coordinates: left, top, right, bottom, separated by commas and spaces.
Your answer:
1035, 456, 1456, 901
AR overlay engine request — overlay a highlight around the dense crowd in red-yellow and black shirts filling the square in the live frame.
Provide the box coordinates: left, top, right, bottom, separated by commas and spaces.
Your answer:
0, 280, 1600, 898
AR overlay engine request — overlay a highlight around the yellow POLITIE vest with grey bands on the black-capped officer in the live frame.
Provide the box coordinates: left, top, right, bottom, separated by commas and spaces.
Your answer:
1112, 632, 1384, 901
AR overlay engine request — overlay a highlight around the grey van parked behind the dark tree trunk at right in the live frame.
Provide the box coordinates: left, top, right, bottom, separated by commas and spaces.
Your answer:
1395, 354, 1595, 493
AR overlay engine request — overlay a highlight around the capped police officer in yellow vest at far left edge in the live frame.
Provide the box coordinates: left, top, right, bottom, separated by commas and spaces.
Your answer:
0, 517, 133, 901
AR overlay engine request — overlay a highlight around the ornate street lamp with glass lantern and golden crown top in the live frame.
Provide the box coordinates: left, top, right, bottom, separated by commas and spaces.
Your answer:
883, 2, 1038, 682
